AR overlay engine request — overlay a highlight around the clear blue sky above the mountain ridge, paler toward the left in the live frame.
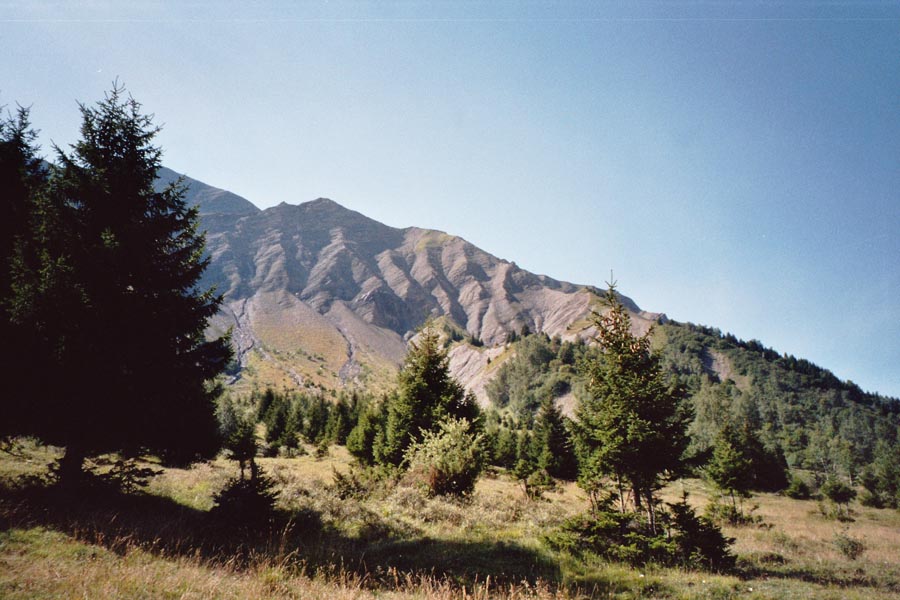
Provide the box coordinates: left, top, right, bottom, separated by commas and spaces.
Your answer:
0, 0, 900, 396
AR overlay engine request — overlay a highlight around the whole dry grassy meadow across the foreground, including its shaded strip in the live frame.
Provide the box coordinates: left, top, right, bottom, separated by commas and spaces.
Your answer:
0, 441, 900, 600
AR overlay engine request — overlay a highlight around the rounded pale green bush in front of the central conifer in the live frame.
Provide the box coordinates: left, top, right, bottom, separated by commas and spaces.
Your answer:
405, 417, 484, 496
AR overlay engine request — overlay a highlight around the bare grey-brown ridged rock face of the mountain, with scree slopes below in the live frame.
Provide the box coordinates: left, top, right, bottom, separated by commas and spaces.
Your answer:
179, 172, 659, 396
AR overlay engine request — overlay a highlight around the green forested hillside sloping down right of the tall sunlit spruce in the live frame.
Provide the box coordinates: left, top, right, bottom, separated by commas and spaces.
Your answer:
656, 323, 900, 480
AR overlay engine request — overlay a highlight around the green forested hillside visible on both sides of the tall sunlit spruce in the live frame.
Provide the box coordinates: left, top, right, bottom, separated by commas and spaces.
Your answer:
485, 321, 900, 506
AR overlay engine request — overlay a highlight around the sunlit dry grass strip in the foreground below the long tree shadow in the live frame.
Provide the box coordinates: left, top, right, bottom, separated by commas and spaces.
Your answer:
0, 527, 572, 600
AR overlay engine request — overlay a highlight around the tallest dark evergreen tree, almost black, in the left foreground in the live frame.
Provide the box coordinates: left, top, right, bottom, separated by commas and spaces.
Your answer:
11, 86, 231, 479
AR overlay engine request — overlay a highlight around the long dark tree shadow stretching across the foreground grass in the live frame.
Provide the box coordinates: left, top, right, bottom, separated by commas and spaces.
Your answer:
0, 484, 560, 588
